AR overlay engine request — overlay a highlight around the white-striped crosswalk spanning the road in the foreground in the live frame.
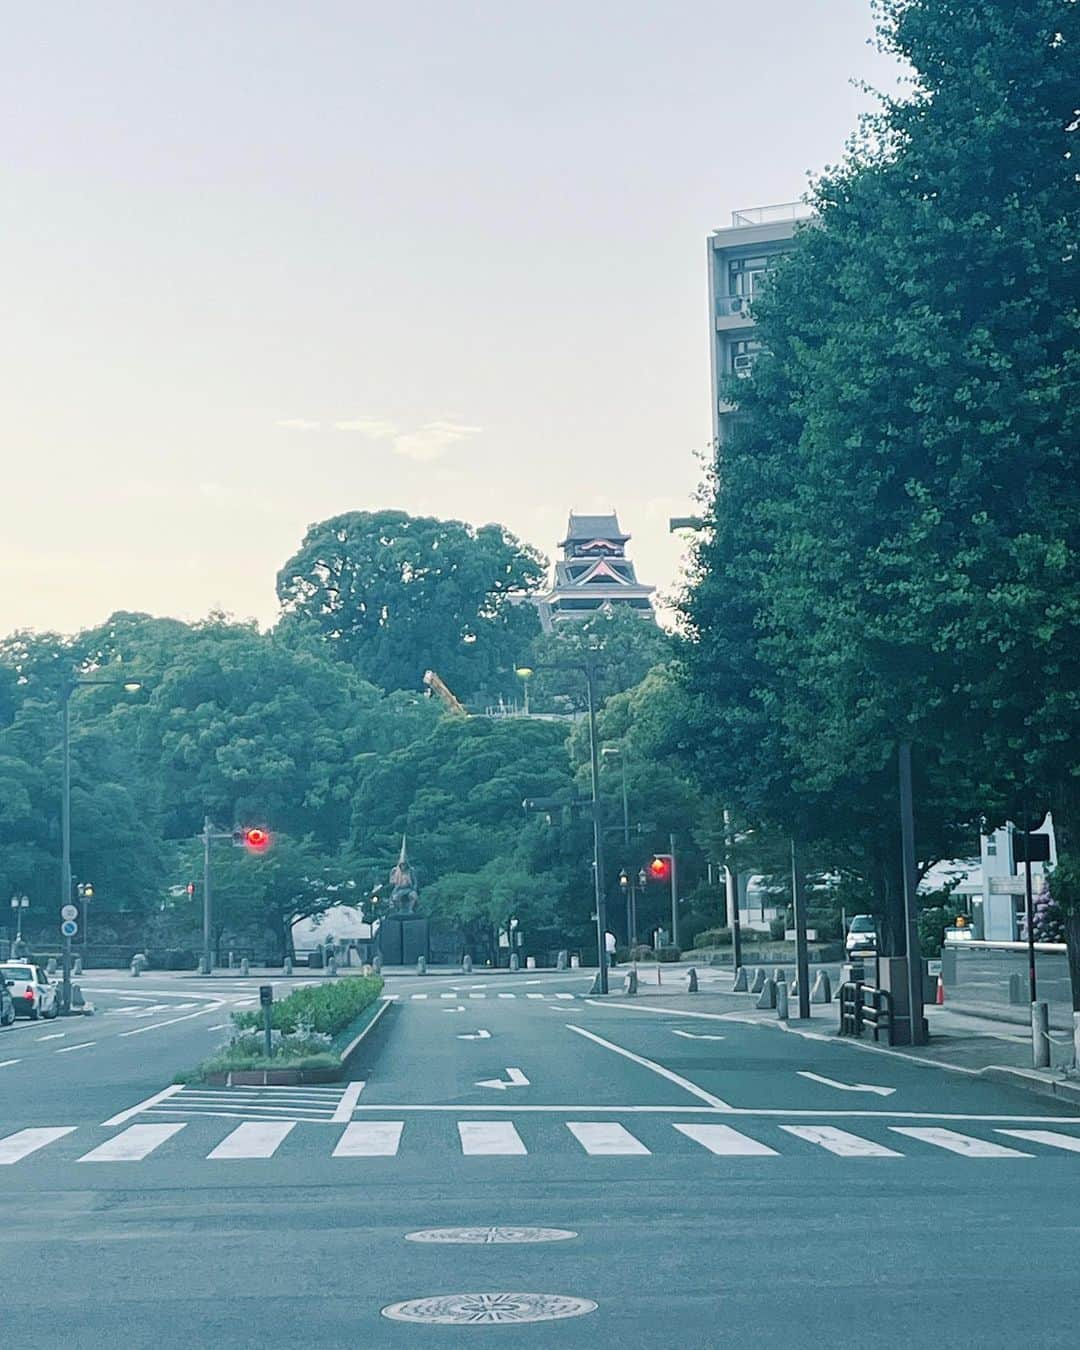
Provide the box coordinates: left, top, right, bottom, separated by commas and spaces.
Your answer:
0, 1118, 1080, 1168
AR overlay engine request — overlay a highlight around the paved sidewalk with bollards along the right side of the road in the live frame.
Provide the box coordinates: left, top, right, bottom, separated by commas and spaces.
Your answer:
597, 965, 1080, 1110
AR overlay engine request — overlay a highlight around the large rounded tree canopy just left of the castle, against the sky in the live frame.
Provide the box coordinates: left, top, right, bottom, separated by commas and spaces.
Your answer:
278, 510, 544, 699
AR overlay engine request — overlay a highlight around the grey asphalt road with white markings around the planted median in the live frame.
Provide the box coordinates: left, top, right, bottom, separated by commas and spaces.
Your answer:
0, 972, 1080, 1350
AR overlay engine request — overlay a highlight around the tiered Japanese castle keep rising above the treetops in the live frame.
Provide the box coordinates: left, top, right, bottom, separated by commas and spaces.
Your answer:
537, 512, 656, 632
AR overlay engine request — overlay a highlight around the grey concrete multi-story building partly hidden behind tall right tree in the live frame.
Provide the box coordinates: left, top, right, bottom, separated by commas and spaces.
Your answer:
709, 201, 810, 443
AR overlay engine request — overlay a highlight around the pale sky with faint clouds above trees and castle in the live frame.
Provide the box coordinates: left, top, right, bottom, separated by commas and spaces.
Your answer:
0, 0, 895, 633
